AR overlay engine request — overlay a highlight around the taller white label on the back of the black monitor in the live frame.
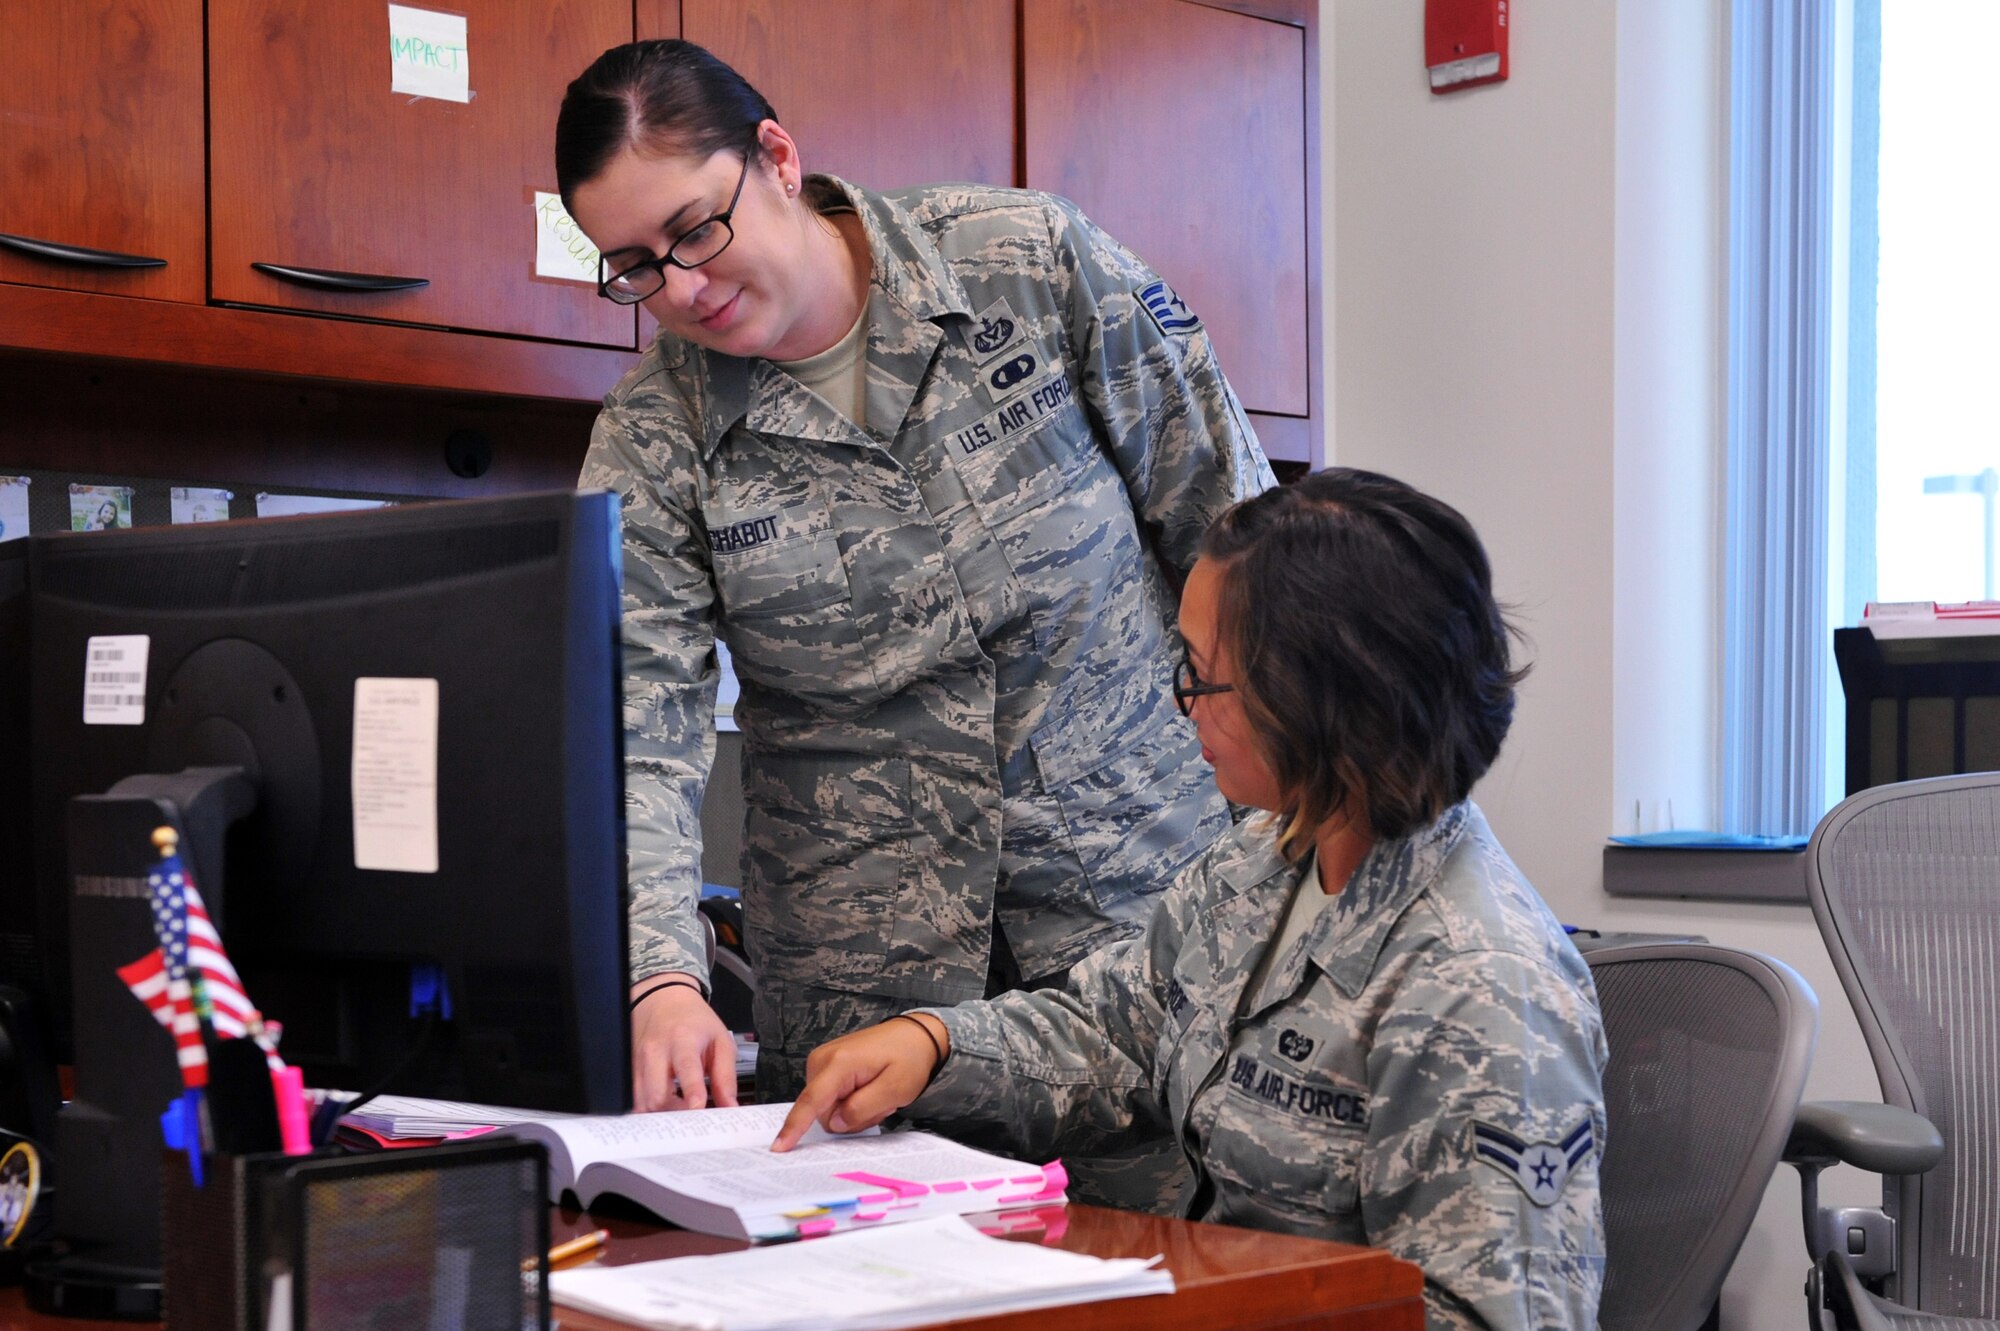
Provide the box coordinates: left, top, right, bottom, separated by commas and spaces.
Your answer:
354, 679, 438, 873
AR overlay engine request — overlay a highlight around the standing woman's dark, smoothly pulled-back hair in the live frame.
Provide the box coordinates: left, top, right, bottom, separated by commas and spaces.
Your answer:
556, 38, 778, 208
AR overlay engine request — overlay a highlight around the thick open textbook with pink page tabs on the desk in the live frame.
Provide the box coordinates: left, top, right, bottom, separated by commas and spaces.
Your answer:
342, 1095, 1068, 1239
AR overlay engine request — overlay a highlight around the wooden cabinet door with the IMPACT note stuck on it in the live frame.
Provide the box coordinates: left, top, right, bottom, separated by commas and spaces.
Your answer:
208, 0, 636, 347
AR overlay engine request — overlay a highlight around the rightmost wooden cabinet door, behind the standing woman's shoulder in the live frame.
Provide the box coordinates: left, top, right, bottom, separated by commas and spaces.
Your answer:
1022, 0, 1312, 416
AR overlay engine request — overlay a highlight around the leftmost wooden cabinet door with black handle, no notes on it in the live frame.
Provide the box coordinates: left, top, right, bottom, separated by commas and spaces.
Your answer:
0, 0, 208, 300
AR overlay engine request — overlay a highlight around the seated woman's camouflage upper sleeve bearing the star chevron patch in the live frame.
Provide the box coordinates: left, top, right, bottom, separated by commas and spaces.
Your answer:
1358, 951, 1606, 1331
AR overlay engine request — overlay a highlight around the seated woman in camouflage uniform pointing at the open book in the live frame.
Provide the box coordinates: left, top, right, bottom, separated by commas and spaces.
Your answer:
776, 470, 1606, 1327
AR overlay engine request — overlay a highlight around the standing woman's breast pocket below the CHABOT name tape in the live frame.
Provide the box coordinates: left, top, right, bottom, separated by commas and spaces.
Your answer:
714, 532, 880, 711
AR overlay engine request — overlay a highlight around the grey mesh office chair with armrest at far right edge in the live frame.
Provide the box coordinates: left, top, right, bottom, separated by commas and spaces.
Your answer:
1788, 771, 2000, 1331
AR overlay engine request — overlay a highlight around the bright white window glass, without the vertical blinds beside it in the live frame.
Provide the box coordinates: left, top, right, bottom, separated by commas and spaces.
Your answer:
1846, 0, 2000, 599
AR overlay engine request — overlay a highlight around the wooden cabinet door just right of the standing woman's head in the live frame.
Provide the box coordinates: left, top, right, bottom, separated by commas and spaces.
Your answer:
676, 0, 1016, 190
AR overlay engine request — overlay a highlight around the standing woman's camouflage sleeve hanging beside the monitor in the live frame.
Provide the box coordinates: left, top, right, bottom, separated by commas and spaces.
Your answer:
578, 400, 718, 983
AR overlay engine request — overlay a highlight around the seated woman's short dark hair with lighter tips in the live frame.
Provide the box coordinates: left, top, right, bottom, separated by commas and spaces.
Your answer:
1202, 468, 1528, 857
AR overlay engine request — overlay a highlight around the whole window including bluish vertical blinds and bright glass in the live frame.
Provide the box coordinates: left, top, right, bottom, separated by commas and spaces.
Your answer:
1722, 0, 2000, 835
